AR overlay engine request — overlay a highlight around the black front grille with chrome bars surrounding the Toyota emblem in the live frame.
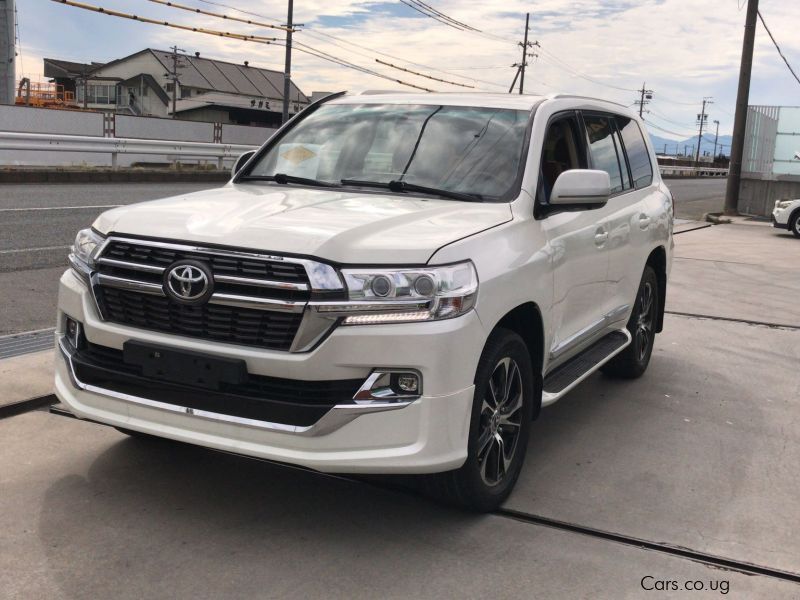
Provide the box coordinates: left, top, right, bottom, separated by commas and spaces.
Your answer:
91, 237, 335, 352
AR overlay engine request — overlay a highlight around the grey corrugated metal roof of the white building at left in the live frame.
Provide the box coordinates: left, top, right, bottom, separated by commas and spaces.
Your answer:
150, 49, 309, 102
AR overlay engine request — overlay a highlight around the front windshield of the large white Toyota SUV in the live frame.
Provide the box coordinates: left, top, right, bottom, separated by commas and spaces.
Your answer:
247, 104, 529, 200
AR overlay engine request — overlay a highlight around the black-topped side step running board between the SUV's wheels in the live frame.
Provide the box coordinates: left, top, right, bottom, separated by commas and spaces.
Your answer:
542, 329, 631, 406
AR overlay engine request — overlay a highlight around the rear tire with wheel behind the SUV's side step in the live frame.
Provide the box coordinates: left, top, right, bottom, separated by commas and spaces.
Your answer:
600, 265, 661, 379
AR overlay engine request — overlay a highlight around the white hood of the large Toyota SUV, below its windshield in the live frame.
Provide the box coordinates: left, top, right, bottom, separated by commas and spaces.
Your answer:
94, 183, 512, 264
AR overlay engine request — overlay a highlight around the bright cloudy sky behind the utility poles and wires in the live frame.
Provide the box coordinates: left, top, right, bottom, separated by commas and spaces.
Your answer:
10, 0, 800, 139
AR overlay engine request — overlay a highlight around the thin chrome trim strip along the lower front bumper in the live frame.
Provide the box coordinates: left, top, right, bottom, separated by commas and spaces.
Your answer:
58, 335, 414, 437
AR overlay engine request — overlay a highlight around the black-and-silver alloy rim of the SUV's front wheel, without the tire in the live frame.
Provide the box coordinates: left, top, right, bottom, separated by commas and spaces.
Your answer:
477, 357, 523, 486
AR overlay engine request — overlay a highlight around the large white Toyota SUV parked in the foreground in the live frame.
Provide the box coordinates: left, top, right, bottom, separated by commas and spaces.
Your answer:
56, 94, 673, 510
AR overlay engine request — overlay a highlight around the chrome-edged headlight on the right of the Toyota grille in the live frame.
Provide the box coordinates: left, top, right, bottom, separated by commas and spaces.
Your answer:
316, 261, 478, 325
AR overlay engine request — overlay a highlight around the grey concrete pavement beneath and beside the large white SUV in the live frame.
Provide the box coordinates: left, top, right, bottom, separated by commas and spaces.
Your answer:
0, 210, 800, 598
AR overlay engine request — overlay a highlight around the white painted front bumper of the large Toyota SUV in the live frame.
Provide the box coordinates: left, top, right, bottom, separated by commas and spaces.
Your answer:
56, 271, 486, 473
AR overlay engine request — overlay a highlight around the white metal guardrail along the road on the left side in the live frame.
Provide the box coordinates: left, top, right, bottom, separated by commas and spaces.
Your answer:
0, 131, 258, 169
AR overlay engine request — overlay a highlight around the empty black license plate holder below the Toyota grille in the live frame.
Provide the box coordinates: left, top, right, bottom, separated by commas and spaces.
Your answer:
122, 340, 247, 390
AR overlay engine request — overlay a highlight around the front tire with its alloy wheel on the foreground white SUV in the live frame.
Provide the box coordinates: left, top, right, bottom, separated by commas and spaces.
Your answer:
429, 329, 535, 512
